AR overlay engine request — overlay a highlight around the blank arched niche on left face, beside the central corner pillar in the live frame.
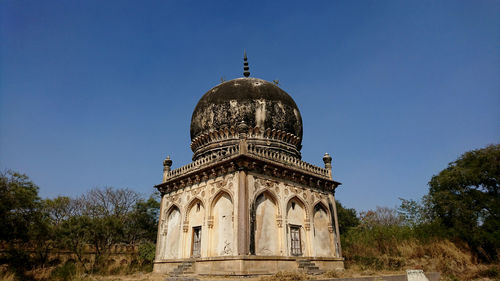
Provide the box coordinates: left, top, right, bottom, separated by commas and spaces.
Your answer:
211, 191, 235, 256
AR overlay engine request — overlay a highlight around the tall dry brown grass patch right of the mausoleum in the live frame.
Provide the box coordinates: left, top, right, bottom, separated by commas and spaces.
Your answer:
339, 236, 500, 281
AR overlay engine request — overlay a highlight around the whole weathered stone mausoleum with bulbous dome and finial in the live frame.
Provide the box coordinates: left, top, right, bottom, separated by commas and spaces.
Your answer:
154, 55, 343, 275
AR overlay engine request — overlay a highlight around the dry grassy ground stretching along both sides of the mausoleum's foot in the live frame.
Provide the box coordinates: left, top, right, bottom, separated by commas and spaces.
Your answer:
0, 239, 500, 281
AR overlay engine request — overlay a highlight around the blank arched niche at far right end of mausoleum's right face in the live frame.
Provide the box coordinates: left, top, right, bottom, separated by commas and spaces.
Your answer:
313, 202, 333, 257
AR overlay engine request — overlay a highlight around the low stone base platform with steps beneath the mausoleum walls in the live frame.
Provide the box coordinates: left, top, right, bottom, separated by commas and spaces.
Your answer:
153, 256, 344, 276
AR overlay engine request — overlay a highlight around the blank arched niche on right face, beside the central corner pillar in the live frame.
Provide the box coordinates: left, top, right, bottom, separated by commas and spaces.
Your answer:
250, 190, 280, 256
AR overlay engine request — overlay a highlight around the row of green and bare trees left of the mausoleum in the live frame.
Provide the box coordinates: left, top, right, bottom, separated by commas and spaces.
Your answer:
0, 171, 159, 274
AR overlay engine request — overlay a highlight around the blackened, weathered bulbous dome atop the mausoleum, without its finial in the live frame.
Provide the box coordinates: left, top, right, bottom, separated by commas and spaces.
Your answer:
191, 78, 302, 159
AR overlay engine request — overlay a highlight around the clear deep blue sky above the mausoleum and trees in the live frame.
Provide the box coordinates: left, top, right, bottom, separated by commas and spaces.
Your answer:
0, 0, 500, 210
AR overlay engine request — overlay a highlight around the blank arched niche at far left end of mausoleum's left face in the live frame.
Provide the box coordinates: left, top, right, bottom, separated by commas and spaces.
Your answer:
162, 205, 182, 259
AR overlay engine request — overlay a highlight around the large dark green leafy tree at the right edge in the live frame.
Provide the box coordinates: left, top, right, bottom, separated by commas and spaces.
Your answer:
428, 144, 500, 260
